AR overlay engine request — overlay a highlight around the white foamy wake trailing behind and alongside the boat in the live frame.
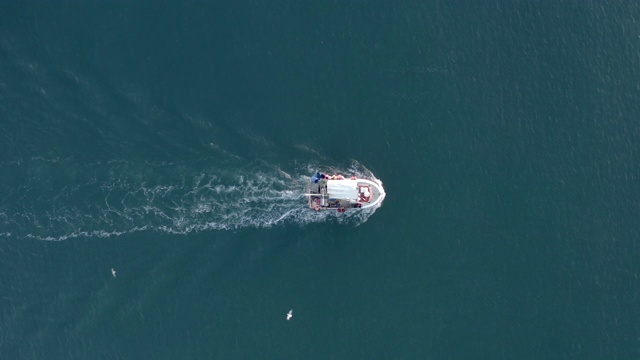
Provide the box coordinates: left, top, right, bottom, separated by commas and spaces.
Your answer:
0, 158, 375, 241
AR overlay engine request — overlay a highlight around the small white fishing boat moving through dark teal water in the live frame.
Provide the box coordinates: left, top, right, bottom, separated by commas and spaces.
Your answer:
305, 172, 386, 212
